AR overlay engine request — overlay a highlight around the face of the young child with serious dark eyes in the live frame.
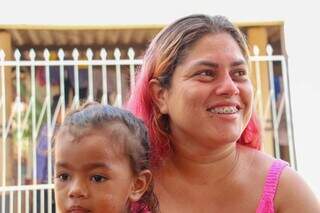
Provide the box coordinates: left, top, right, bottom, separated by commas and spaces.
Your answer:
54, 131, 142, 213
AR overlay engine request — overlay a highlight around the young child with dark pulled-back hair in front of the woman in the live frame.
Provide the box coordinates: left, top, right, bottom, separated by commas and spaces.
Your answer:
54, 103, 157, 213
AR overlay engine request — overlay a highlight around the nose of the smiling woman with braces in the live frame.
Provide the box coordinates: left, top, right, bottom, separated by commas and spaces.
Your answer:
216, 75, 240, 96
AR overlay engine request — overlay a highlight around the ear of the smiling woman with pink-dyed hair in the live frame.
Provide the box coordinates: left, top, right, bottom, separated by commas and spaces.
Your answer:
149, 79, 168, 114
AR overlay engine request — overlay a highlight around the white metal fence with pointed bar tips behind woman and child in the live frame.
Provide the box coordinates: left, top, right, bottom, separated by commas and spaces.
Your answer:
0, 46, 295, 213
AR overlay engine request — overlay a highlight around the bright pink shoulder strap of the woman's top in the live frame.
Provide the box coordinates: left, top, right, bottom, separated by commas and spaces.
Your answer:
256, 160, 288, 213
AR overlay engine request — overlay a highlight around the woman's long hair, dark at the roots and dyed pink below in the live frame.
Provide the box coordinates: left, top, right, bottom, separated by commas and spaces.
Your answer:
126, 15, 260, 164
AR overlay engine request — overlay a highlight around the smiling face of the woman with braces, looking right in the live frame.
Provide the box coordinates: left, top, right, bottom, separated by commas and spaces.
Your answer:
160, 33, 253, 147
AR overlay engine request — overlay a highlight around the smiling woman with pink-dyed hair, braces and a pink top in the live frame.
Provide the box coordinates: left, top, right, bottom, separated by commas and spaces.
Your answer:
128, 15, 320, 213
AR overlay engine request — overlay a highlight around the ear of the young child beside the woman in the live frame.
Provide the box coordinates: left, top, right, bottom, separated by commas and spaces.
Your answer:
129, 170, 152, 202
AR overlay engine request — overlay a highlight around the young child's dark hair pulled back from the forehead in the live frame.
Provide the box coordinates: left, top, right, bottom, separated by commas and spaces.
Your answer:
57, 102, 158, 213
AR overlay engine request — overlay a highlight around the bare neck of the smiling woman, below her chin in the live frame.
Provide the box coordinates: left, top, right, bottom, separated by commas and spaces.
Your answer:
157, 143, 239, 183
